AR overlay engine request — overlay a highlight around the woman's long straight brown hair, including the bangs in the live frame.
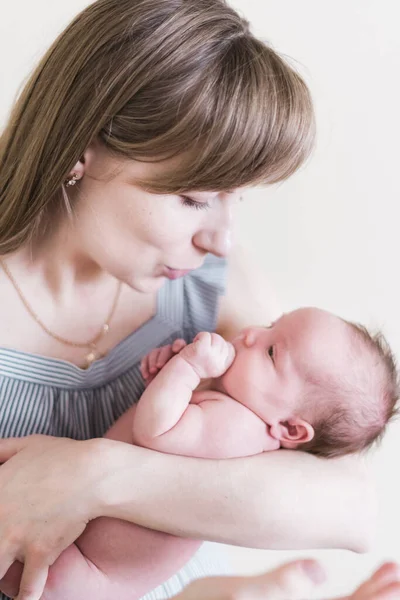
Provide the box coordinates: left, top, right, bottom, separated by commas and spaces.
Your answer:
0, 0, 314, 255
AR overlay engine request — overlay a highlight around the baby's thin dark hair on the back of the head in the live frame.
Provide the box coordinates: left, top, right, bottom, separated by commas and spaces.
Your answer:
301, 321, 400, 458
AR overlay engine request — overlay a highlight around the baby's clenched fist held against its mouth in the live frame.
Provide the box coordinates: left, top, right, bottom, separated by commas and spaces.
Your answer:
180, 332, 235, 379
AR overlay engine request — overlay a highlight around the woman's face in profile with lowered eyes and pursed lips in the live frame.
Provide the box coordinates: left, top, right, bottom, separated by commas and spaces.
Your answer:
68, 145, 239, 292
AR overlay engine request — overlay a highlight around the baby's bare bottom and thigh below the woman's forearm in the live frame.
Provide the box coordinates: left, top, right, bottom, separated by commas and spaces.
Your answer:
49, 406, 200, 600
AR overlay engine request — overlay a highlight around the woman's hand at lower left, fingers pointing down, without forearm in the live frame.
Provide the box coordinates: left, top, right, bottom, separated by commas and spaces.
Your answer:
0, 435, 104, 600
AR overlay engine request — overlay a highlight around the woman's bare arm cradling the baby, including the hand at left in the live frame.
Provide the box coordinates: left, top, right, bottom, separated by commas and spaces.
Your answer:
0, 436, 376, 600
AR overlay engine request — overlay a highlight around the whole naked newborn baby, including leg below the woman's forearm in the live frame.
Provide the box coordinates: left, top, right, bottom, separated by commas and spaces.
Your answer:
6, 308, 398, 600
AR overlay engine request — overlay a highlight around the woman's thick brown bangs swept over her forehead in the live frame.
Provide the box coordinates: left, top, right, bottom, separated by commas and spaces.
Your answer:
126, 37, 315, 193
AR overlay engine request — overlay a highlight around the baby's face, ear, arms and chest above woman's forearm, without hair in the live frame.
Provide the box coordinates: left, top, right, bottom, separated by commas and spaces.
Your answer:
134, 308, 358, 458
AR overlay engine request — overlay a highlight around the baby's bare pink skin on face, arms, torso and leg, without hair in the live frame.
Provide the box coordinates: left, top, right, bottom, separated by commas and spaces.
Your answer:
0, 308, 368, 600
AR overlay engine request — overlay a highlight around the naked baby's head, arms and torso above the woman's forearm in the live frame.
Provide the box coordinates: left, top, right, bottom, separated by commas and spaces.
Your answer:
137, 308, 397, 458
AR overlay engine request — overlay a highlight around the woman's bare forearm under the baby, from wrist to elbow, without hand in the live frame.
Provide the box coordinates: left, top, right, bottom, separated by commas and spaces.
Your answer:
93, 440, 376, 552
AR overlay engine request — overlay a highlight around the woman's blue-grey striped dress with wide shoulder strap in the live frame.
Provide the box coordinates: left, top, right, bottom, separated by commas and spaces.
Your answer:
0, 255, 229, 600
